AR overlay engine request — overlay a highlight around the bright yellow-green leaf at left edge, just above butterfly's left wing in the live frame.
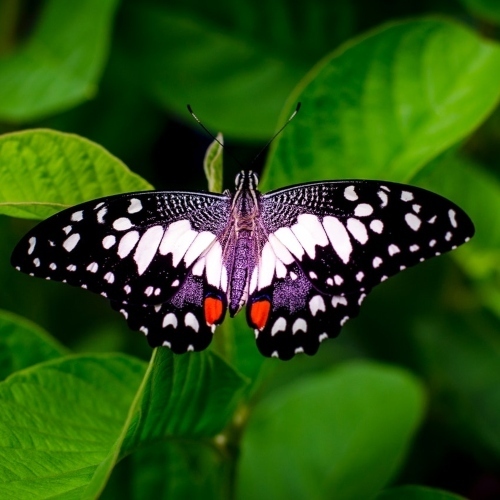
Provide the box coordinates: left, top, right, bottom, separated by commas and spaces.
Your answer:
0, 130, 151, 219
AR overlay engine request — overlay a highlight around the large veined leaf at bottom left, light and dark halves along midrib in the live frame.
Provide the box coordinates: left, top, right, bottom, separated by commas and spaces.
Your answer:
0, 349, 246, 499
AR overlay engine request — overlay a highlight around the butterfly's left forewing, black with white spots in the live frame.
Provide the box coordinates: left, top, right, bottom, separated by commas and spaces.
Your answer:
11, 191, 230, 305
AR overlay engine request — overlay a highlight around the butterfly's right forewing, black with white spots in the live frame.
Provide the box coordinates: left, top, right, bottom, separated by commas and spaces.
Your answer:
261, 180, 474, 295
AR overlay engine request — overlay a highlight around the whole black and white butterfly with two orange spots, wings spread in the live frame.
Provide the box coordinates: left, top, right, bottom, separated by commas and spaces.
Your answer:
11, 171, 474, 360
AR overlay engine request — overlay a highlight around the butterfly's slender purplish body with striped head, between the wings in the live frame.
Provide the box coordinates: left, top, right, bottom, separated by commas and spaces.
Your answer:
224, 171, 261, 316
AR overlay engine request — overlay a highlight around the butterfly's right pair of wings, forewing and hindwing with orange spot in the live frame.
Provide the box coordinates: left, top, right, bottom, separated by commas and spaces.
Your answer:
247, 180, 474, 359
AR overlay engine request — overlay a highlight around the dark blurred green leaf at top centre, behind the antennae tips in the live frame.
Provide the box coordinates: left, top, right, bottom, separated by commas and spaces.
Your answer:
123, 0, 354, 140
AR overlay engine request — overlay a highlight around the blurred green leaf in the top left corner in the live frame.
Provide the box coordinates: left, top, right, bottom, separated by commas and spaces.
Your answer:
0, 0, 118, 122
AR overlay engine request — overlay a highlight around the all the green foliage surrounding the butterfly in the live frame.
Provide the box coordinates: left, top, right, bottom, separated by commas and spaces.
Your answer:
0, 0, 500, 500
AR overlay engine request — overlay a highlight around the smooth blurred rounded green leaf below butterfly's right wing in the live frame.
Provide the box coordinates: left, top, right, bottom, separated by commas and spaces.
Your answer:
238, 362, 424, 500
